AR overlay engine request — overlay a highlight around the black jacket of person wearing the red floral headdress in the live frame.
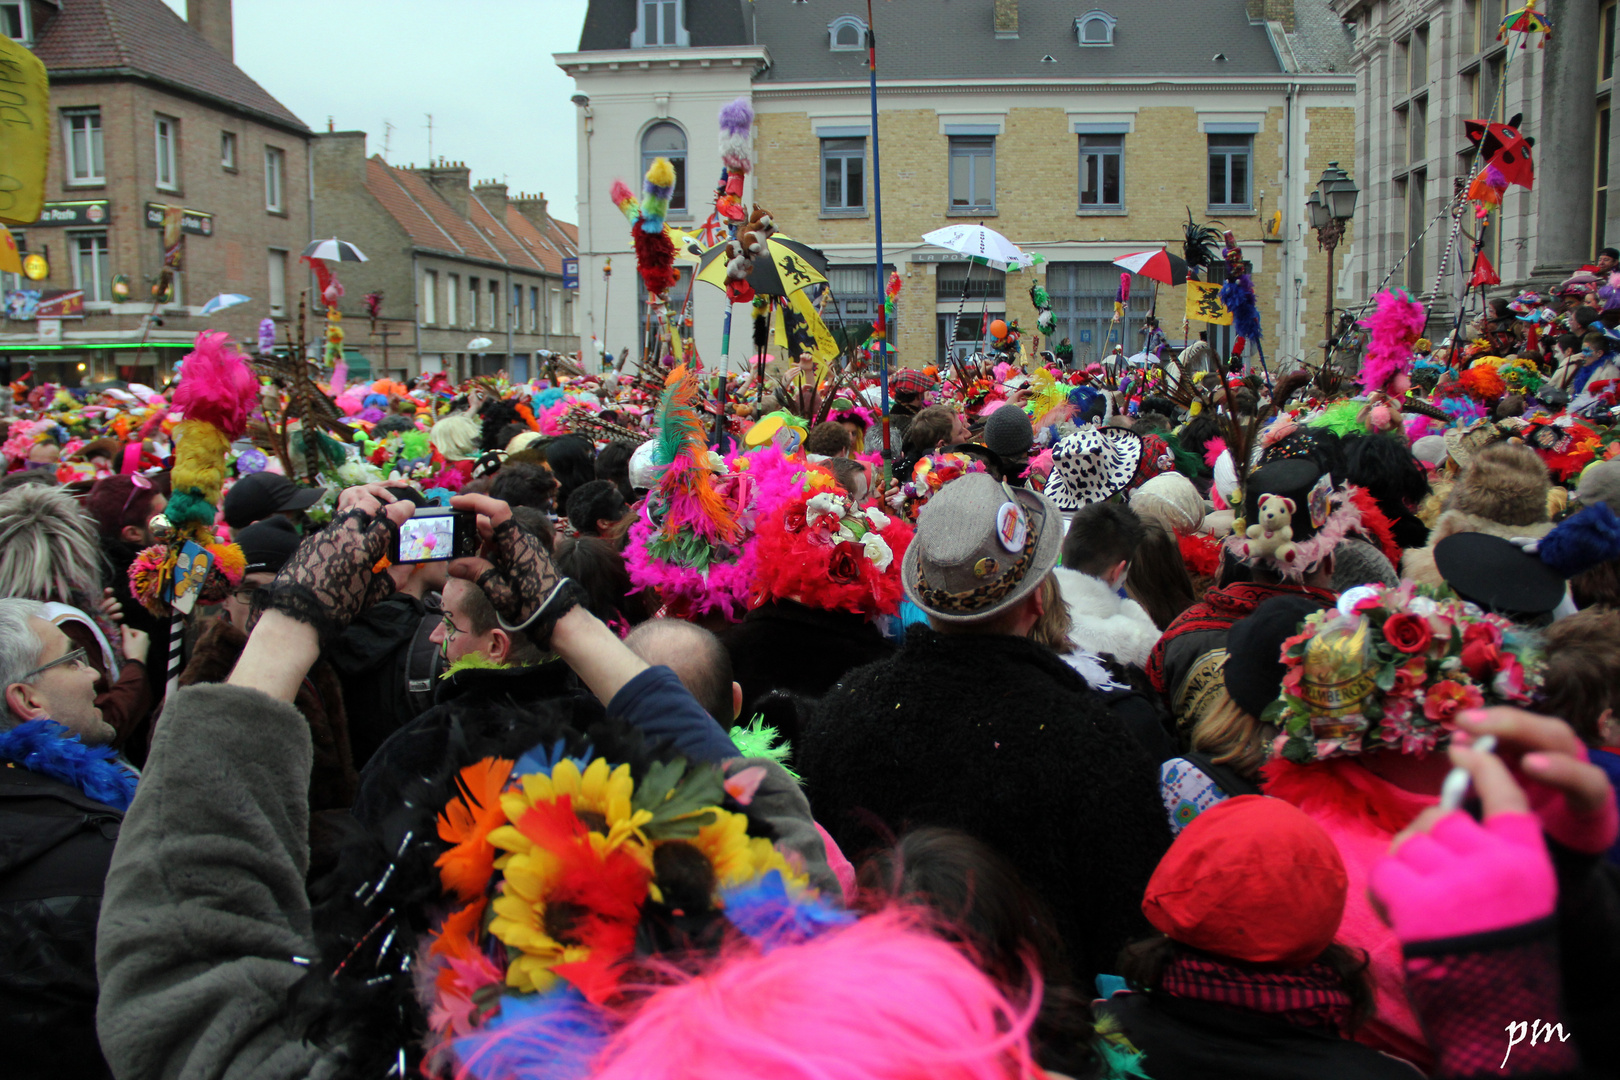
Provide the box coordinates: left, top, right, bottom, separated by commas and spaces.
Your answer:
719, 601, 894, 742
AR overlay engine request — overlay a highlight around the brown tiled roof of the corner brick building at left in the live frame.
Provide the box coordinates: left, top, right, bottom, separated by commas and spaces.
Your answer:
34, 0, 309, 131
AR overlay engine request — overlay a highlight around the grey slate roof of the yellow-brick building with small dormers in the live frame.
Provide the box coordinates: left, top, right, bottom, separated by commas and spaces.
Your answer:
751, 0, 1283, 83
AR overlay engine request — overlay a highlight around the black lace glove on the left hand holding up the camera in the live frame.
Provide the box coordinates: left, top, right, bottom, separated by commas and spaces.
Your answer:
267, 508, 399, 644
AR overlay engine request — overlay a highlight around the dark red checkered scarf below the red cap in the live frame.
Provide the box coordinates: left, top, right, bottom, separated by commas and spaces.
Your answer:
1160, 955, 1349, 1035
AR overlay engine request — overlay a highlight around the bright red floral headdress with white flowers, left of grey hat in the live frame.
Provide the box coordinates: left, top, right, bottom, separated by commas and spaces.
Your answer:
755, 470, 912, 615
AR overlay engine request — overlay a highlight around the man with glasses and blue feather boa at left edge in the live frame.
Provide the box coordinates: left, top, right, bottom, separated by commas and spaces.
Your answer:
0, 599, 134, 1077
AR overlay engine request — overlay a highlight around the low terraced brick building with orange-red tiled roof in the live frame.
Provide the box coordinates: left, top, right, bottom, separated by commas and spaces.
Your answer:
309, 131, 578, 379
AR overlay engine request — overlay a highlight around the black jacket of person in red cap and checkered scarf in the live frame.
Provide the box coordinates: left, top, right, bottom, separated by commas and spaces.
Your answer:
1092, 994, 1422, 1080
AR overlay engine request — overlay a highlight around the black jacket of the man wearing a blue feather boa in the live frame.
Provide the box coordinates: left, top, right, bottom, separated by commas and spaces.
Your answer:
0, 766, 123, 1080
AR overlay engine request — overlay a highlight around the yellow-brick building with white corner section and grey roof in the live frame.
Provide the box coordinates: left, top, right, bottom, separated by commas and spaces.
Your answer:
556, 0, 1356, 372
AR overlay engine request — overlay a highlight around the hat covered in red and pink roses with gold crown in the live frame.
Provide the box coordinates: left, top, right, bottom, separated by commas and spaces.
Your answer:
1260, 581, 1541, 764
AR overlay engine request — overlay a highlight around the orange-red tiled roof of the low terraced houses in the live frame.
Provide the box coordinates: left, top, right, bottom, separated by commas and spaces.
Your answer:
366, 155, 578, 274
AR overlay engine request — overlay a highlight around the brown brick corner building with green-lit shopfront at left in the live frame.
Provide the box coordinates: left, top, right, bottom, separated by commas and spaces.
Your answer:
0, 0, 311, 385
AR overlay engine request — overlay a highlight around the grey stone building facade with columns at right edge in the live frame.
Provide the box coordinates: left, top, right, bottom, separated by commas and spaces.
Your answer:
1333, 0, 1620, 322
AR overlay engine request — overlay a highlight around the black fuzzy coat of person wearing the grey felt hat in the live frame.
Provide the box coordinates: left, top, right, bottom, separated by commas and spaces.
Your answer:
794, 627, 1170, 984
